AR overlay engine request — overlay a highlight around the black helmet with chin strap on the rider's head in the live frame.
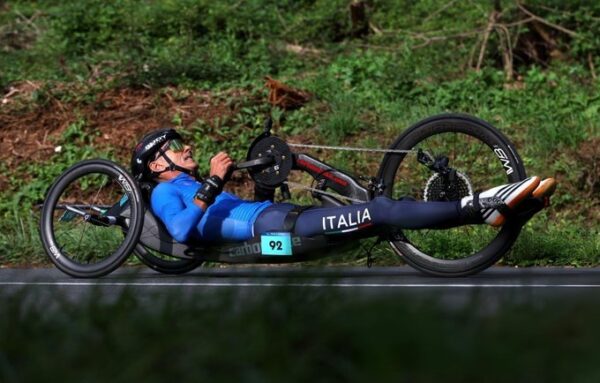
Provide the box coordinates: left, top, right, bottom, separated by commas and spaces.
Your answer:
131, 128, 183, 181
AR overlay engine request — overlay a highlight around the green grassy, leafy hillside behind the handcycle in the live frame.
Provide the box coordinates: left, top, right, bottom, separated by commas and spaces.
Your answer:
0, 0, 600, 265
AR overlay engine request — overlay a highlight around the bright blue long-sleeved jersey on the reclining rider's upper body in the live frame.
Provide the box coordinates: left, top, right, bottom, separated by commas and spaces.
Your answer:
150, 173, 272, 242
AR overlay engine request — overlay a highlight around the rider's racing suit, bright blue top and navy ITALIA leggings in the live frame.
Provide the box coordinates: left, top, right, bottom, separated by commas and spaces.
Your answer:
151, 173, 464, 242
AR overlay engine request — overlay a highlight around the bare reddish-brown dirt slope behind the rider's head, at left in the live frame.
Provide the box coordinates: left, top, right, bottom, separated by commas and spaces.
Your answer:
0, 82, 232, 166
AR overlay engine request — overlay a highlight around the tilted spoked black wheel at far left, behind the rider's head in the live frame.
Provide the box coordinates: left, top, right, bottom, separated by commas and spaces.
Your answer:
40, 160, 144, 278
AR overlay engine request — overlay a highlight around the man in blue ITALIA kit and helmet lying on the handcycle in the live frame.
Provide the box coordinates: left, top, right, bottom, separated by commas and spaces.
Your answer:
131, 129, 556, 242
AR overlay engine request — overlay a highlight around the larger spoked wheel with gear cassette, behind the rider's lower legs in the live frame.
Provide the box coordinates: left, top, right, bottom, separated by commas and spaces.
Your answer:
379, 114, 525, 276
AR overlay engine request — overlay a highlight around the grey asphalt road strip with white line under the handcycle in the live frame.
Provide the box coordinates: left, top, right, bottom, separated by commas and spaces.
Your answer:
0, 266, 600, 309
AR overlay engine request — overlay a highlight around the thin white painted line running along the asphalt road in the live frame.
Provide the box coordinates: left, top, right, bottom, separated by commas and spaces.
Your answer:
0, 282, 600, 289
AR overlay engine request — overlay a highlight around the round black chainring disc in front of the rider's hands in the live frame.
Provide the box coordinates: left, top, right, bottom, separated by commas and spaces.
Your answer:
246, 135, 293, 187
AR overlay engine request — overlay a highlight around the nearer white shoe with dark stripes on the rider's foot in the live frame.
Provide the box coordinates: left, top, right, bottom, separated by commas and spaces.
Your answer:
460, 176, 540, 226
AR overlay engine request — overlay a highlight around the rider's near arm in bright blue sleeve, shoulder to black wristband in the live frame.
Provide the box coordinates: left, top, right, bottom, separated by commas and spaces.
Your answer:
151, 184, 206, 242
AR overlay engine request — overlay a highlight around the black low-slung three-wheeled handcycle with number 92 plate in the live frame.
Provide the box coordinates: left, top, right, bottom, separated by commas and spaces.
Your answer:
40, 114, 539, 278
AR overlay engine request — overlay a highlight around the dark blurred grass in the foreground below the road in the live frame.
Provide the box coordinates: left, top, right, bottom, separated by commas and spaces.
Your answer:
0, 287, 600, 382
